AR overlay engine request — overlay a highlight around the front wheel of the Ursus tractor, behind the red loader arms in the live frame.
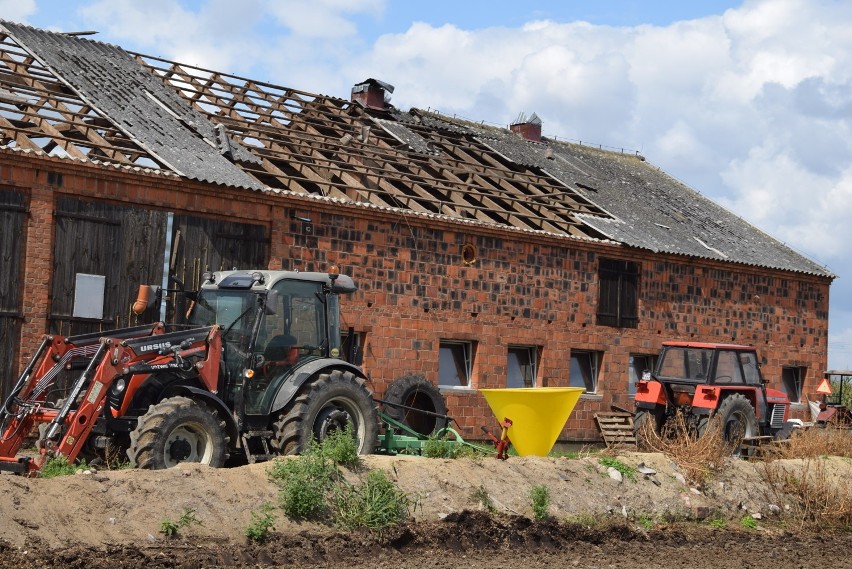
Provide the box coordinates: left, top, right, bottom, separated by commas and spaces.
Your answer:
127, 397, 230, 470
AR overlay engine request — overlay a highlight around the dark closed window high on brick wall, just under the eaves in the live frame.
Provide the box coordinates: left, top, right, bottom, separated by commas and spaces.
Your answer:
598, 259, 639, 328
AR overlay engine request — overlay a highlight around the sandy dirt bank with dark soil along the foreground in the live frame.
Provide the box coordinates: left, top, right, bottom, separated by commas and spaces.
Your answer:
0, 453, 852, 569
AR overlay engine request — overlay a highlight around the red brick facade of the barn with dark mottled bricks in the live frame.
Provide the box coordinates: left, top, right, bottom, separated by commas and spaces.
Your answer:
0, 151, 830, 441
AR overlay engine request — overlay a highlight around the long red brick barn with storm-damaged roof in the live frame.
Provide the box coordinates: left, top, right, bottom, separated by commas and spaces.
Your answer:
0, 22, 834, 441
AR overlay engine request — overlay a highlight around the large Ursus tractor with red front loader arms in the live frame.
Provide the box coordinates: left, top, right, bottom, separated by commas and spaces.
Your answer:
0, 267, 379, 475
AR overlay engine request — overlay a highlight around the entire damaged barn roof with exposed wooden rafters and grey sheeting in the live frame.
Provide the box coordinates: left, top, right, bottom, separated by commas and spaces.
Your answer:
0, 21, 834, 278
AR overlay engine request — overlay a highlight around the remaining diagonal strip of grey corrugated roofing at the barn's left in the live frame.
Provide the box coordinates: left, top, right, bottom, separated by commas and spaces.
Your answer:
0, 21, 263, 189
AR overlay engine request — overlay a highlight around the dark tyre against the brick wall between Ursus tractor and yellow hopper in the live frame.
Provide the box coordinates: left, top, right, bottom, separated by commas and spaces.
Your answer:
383, 375, 447, 436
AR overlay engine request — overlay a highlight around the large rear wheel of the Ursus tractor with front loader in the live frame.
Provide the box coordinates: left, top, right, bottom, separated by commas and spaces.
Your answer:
273, 370, 379, 454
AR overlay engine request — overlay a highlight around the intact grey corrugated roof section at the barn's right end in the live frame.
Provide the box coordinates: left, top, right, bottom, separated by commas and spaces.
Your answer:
479, 132, 834, 277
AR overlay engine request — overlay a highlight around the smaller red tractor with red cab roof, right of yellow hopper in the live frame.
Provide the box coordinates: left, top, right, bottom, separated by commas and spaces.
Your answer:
634, 342, 796, 455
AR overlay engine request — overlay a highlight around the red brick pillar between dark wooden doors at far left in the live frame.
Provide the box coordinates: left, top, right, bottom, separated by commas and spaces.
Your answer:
19, 185, 54, 369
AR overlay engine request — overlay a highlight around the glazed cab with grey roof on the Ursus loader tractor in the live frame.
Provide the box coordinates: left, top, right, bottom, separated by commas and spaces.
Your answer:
189, 271, 356, 416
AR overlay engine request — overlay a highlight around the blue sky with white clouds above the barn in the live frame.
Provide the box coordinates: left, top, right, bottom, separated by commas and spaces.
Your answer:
5, 0, 852, 369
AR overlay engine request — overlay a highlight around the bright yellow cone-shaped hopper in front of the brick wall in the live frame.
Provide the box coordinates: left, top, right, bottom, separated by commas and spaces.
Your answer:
479, 387, 584, 456
